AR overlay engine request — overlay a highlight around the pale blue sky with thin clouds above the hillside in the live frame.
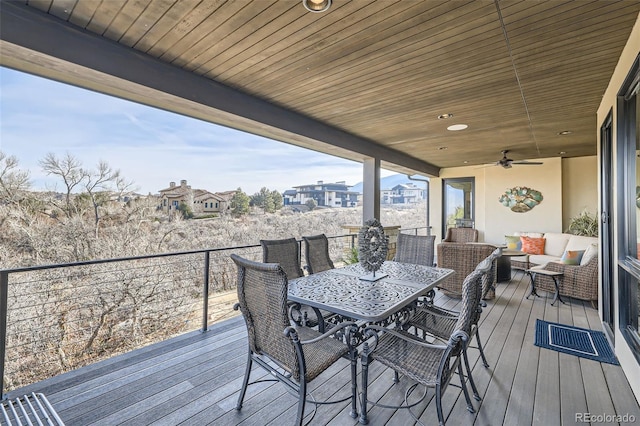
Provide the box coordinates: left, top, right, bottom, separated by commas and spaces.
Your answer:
0, 67, 400, 194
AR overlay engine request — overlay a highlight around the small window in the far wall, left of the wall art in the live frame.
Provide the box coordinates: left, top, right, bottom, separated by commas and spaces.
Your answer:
442, 177, 475, 235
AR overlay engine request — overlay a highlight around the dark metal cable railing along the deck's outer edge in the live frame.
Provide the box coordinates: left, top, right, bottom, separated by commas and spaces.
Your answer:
0, 228, 425, 395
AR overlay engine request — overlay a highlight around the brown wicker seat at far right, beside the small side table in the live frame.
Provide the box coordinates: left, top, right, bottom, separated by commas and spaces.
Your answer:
536, 255, 598, 303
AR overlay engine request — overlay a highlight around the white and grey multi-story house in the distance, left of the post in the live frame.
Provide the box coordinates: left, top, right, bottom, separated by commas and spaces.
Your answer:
282, 180, 358, 207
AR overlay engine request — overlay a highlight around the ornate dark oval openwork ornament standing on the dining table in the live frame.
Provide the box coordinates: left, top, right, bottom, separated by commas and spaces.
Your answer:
358, 218, 389, 281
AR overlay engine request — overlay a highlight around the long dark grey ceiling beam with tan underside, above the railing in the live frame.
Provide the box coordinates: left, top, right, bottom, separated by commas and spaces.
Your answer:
0, 2, 440, 176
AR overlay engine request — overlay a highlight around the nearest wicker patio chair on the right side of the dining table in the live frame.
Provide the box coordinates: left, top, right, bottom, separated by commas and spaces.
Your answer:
360, 270, 483, 425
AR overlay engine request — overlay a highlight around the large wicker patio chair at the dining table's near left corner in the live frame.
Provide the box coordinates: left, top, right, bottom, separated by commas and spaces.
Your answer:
231, 254, 357, 425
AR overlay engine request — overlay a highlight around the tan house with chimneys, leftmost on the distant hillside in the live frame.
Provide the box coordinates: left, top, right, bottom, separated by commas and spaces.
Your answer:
159, 179, 236, 214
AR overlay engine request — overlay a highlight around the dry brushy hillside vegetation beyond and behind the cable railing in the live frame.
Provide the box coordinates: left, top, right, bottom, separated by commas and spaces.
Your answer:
0, 152, 426, 391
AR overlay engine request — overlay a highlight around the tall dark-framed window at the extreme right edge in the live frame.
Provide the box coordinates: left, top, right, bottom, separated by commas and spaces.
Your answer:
616, 56, 640, 361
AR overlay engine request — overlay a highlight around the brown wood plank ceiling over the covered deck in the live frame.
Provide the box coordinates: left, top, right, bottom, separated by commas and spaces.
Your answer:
1, 0, 640, 174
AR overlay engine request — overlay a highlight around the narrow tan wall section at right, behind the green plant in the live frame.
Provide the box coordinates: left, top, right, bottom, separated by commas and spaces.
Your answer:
562, 155, 599, 229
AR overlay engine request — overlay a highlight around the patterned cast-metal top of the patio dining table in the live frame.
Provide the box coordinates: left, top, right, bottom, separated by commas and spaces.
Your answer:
288, 261, 454, 323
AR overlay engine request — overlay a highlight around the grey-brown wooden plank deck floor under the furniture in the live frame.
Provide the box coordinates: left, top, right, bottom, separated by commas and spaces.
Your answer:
8, 272, 640, 426
